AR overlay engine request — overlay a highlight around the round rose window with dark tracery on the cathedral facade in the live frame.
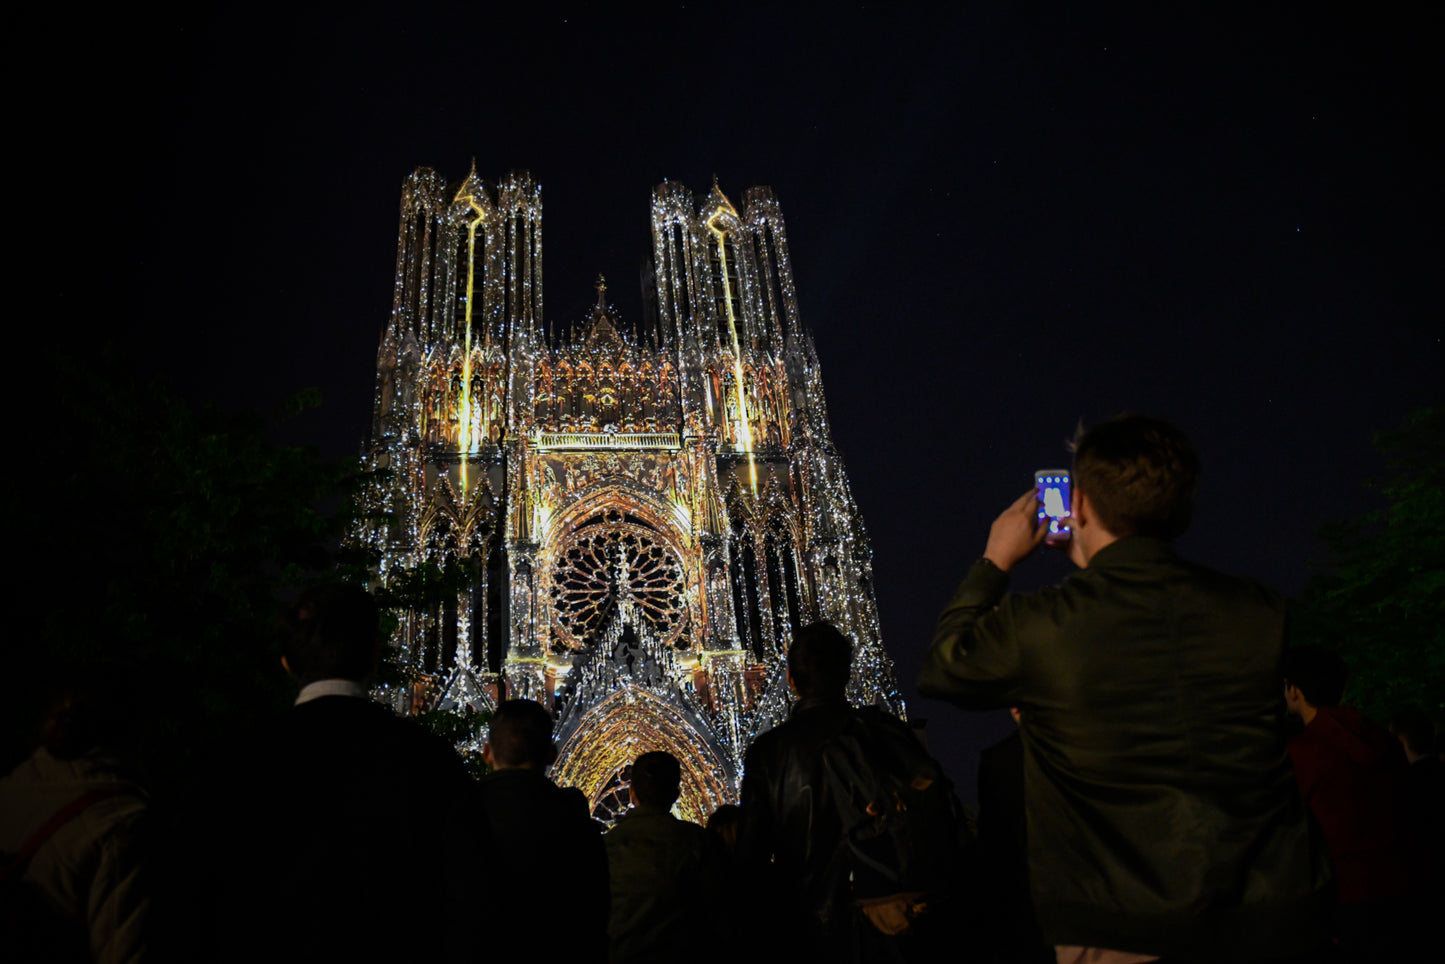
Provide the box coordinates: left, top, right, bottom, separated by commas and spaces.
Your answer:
552, 512, 688, 649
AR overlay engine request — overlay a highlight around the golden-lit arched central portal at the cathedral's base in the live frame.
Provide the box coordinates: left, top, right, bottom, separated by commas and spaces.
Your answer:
552, 682, 736, 824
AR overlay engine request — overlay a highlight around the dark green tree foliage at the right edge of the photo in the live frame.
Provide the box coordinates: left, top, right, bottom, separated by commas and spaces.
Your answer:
1296, 409, 1445, 726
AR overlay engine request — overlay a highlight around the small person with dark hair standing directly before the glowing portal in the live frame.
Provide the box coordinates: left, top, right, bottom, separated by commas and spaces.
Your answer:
605, 750, 725, 964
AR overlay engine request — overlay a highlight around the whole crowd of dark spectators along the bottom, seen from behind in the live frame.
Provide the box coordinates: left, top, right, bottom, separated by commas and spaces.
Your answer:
0, 416, 1445, 964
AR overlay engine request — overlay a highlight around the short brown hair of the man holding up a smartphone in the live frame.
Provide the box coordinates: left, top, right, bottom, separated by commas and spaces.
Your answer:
1074, 415, 1199, 539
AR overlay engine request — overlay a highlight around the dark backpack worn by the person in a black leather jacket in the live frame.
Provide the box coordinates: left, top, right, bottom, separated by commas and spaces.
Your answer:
819, 707, 968, 935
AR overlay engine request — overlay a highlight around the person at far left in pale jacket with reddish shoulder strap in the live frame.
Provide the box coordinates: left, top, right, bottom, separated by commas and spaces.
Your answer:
0, 671, 150, 964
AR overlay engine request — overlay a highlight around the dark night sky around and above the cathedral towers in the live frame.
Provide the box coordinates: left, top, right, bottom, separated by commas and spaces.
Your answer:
39, 3, 1442, 788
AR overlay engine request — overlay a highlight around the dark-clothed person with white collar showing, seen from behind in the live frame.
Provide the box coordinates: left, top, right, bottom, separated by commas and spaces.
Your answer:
197, 585, 486, 961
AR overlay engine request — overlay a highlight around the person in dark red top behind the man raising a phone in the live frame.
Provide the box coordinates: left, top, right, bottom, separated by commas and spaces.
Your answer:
1282, 646, 1423, 961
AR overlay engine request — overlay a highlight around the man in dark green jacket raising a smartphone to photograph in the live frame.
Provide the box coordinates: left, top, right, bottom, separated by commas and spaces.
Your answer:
919, 416, 1325, 964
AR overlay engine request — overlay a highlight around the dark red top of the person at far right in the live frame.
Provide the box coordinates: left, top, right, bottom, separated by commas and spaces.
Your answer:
1289, 707, 1415, 903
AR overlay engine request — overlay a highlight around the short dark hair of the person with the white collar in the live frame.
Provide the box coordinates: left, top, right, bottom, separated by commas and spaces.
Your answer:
282, 584, 381, 685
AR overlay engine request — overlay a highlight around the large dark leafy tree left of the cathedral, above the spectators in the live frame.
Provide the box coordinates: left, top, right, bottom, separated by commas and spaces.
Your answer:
6, 351, 357, 780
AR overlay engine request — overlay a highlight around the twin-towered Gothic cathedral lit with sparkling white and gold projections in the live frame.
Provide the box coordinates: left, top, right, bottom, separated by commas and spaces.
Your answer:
354, 168, 905, 819
